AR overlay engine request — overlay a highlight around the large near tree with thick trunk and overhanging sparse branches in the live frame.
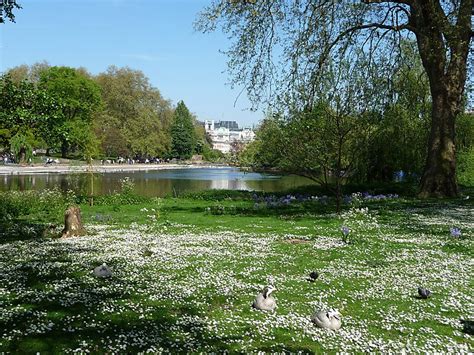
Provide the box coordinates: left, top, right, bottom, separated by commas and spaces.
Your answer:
197, 0, 474, 196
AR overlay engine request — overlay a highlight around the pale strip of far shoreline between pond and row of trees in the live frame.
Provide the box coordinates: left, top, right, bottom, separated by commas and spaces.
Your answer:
0, 163, 231, 175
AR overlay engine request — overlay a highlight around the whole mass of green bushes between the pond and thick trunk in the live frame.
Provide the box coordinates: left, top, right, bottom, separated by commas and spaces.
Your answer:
244, 42, 436, 191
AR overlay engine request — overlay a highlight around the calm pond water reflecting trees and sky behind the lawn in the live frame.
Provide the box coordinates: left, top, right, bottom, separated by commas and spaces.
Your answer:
0, 167, 312, 197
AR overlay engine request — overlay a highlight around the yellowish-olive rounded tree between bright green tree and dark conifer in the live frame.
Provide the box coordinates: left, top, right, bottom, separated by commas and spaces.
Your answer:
95, 66, 172, 157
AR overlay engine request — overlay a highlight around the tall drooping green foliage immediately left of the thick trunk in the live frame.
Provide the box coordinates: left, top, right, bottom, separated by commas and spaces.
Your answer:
355, 42, 431, 181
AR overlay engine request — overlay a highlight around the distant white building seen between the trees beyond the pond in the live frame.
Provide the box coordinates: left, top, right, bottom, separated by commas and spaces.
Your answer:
204, 120, 255, 153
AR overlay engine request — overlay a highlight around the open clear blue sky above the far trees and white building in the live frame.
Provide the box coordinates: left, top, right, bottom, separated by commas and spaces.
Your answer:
0, 0, 263, 126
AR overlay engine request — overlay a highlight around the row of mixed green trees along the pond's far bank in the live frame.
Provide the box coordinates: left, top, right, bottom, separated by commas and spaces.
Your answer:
0, 63, 215, 162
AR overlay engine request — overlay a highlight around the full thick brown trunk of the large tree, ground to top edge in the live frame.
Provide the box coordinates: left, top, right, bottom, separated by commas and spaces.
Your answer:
409, 0, 474, 197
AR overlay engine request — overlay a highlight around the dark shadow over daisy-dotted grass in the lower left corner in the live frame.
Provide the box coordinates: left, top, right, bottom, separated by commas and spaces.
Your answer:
0, 244, 256, 353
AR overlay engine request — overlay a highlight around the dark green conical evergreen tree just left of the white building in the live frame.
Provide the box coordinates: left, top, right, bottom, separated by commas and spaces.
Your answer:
171, 101, 196, 159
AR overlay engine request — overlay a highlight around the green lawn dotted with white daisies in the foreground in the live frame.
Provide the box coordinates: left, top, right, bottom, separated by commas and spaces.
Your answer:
0, 193, 474, 353
